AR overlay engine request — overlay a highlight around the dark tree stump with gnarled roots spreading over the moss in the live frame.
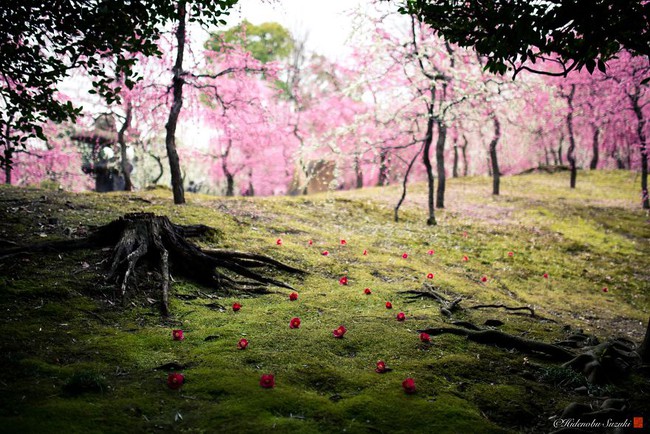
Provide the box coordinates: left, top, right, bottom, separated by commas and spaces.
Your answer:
0, 213, 303, 315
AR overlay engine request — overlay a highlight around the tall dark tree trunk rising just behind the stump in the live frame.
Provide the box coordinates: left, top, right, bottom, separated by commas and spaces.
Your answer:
165, 0, 186, 204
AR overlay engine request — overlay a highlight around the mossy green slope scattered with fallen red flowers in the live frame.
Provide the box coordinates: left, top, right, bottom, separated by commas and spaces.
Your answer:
0, 172, 650, 432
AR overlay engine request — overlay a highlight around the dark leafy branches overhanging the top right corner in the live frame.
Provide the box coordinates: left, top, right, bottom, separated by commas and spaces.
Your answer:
400, 0, 650, 76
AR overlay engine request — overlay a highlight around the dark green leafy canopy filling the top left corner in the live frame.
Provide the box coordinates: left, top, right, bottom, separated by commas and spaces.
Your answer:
0, 0, 237, 170
